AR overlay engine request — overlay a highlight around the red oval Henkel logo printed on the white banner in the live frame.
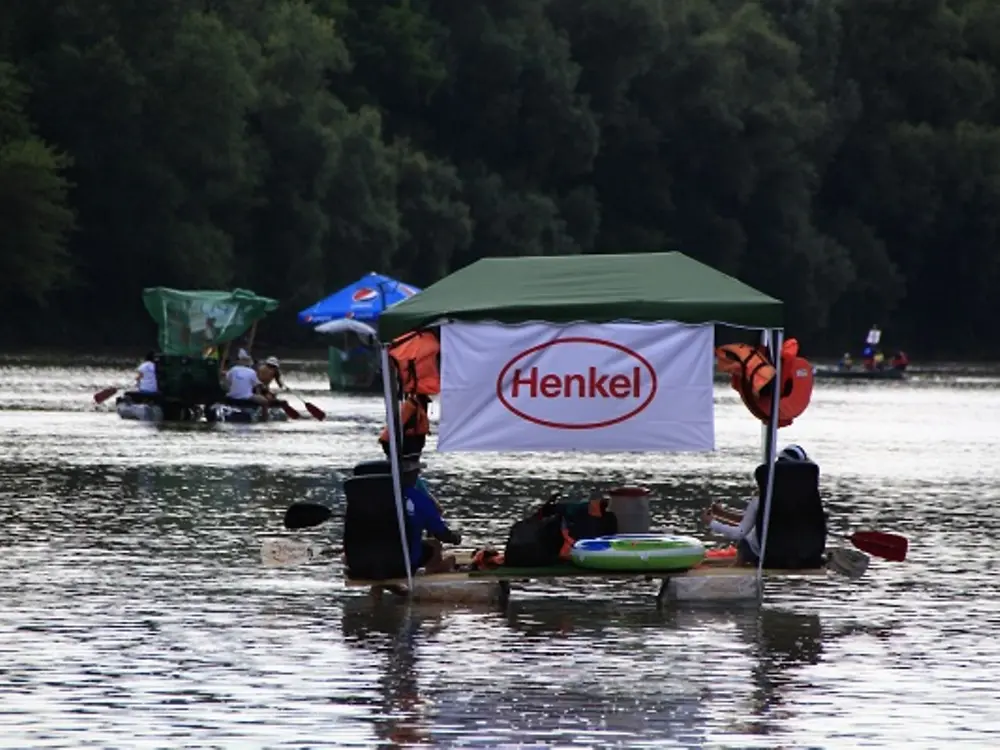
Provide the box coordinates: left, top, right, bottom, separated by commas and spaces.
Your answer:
497, 337, 657, 430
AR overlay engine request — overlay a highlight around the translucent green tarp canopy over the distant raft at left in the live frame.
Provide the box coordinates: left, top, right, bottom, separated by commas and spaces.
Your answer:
142, 286, 278, 357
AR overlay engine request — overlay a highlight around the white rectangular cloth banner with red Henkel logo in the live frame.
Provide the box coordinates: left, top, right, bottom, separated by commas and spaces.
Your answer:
438, 323, 715, 453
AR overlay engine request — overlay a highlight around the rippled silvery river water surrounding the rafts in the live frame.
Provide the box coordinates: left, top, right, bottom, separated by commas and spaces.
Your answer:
0, 358, 1000, 749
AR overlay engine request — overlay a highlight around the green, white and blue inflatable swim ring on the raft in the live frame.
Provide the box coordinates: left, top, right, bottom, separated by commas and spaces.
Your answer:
570, 534, 705, 571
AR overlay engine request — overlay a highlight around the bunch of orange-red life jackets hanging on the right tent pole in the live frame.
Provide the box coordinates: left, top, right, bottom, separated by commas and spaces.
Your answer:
715, 339, 813, 427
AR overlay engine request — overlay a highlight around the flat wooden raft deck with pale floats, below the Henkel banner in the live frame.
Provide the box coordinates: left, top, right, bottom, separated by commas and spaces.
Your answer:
345, 561, 826, 604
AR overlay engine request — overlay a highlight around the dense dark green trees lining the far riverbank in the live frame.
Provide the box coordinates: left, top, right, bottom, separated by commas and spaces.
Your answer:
0, 0, 1000, 356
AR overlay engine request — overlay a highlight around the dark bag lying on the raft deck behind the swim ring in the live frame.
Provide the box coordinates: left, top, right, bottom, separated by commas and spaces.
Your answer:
504, 493, 618, 568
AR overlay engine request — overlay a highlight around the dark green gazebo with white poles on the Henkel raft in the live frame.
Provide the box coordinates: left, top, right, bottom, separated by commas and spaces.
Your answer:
379, 252, 784, 600
